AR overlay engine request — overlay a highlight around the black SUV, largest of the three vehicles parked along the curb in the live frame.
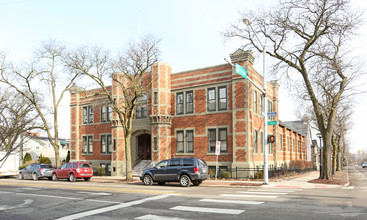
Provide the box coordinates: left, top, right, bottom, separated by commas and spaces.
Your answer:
140, 157, 209, 187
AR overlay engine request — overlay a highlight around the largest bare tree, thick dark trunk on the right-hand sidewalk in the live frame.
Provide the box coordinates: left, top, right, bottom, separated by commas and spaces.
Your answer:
224, 0, 360, 179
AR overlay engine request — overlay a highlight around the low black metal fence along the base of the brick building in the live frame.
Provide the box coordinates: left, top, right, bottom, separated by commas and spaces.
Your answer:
209, 167, 316, 179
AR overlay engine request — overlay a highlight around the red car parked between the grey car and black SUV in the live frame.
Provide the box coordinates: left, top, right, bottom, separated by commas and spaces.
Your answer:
52, 162, 93, 182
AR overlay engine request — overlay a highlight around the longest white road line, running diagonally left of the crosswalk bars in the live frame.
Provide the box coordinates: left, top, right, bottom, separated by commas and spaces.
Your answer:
59, 194, 177, 220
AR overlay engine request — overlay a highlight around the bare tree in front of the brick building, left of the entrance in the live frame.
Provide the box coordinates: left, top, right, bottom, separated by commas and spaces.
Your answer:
68, 35, 159, 180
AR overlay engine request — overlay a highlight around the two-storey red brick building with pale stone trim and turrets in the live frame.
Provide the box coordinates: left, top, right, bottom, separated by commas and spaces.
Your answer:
70, 50, 306, 175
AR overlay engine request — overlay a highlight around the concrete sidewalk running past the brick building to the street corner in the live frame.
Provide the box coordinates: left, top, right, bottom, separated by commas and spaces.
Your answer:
91, 170, 348, 189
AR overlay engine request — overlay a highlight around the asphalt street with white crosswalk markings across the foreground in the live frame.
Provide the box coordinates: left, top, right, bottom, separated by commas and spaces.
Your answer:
0, 167, 367, 220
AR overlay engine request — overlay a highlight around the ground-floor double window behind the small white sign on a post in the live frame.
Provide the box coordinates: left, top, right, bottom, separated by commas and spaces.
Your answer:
208, 128, 228, 153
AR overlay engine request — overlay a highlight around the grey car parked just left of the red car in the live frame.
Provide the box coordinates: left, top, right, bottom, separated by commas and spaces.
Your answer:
18, 163, 54, 180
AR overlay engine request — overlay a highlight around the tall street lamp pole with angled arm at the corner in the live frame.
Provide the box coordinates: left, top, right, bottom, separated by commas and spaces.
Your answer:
242, 18, 269, 185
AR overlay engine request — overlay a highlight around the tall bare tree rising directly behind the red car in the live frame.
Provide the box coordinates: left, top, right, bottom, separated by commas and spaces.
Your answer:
0, 40, 80, 167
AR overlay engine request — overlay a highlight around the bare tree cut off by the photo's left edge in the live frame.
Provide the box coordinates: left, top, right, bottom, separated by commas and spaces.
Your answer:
0, 89, 43, 167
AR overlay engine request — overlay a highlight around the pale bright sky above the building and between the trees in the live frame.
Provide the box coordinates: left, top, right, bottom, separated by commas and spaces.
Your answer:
0, 0, 367, 152
